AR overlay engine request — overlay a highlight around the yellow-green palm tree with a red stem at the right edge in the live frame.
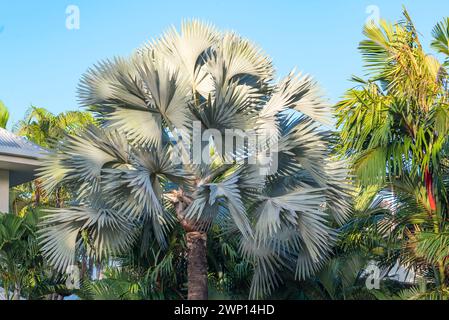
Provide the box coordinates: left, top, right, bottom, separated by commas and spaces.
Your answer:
336, 9, 449, 294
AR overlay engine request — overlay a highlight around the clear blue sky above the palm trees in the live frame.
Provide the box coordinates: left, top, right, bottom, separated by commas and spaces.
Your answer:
0, 0, 449, 123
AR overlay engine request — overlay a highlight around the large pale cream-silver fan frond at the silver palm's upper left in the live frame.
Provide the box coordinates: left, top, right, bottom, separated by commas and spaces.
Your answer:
79, 55, 191, 145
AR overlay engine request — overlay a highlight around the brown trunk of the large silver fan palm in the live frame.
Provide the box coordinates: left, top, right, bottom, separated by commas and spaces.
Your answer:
187, 232, 208, 300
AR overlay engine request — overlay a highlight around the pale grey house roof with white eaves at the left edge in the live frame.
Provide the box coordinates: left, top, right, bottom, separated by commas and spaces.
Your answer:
0, 128, 48, 186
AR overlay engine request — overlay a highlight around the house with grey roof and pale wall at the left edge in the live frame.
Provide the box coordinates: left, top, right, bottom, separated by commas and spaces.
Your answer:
0, 128, 47, 213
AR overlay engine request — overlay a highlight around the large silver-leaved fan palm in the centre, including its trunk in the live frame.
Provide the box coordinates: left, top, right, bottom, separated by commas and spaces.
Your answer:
40, 21, 350, 299
